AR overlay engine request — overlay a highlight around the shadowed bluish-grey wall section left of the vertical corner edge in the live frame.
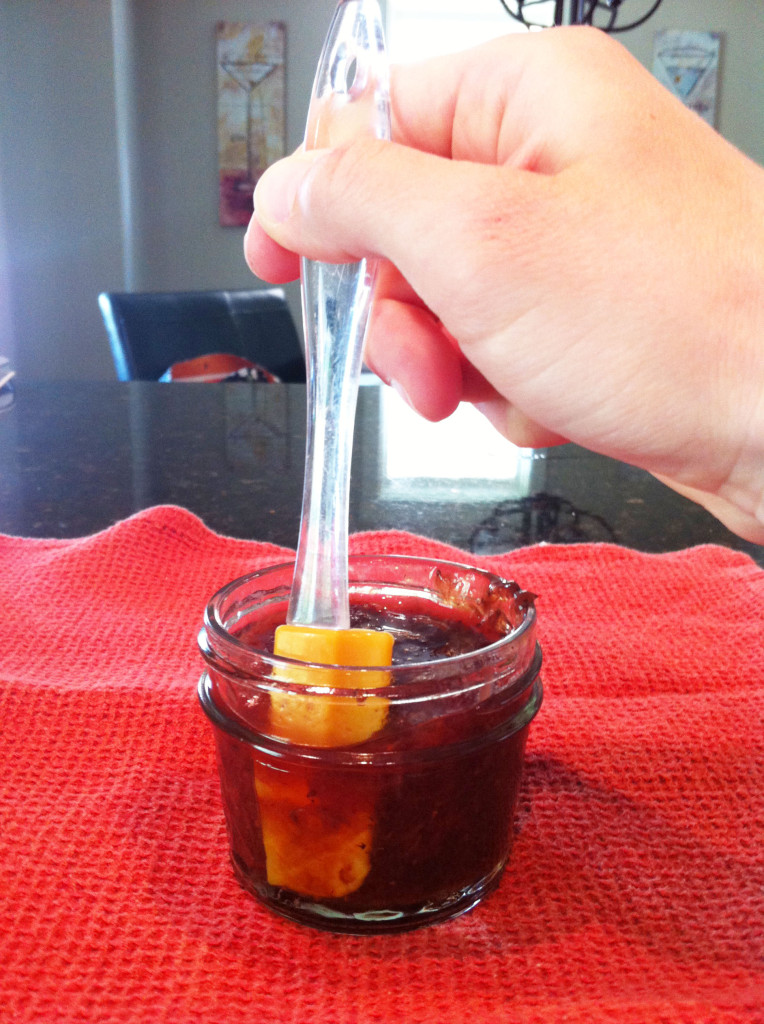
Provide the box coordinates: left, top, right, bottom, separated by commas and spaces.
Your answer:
0, 0, 122, 377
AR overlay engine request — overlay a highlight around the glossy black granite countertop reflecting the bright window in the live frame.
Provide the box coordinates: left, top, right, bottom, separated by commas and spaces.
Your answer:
0, 382, 764, 564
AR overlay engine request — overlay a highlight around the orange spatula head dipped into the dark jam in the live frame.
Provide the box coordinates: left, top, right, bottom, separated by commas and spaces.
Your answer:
255, 625, 393, 899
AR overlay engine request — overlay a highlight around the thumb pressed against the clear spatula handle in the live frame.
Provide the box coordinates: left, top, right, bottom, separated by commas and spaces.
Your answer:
248, 139, 548, 336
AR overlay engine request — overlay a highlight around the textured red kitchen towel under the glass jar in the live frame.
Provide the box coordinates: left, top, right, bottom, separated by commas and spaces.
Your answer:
0, 507, 764, 1024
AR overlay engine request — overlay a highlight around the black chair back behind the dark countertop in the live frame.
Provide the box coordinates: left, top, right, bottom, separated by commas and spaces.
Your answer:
98, 289, 305, 383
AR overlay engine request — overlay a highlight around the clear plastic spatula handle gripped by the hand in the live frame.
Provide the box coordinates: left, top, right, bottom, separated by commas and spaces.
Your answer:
287, 0, 390, 630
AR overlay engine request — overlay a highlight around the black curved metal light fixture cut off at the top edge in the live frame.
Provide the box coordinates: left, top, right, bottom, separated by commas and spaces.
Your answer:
499, 0, 663, 32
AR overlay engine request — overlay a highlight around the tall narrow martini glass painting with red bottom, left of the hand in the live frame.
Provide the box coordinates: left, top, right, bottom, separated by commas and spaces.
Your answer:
217, 22, 287, 227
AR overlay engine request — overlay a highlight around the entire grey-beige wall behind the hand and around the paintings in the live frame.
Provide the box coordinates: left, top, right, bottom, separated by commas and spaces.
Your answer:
0, 0, 764, 379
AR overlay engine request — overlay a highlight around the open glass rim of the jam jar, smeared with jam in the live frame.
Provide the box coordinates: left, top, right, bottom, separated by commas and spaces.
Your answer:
200, 556, 536, 697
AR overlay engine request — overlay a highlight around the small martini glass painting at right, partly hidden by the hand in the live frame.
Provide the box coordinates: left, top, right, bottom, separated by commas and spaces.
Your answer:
652, 30, 721, 126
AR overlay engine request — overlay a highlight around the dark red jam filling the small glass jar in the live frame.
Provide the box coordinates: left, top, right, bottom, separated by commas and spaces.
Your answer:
201, 605, 541, 932
